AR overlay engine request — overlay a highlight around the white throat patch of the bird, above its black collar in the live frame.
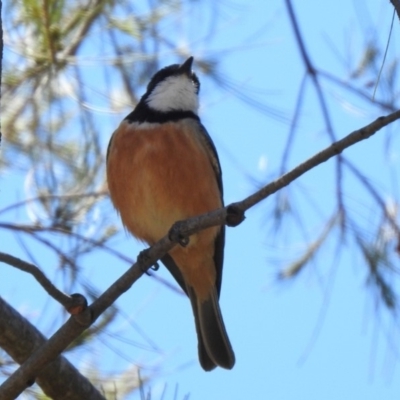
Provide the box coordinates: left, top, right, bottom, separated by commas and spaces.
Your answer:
146, 75, 199, 114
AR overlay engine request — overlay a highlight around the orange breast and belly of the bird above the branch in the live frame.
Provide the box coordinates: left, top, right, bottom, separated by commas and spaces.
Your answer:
107, 119, 222, 244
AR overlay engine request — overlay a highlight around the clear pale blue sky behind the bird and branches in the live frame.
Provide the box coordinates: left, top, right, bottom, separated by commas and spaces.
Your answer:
0, 0, 400, 400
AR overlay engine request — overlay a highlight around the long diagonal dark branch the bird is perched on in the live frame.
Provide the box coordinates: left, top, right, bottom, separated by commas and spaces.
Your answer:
0, 111, 400, 400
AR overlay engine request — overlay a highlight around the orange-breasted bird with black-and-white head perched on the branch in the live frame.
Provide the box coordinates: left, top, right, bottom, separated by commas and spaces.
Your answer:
106, 57, 235, 371
